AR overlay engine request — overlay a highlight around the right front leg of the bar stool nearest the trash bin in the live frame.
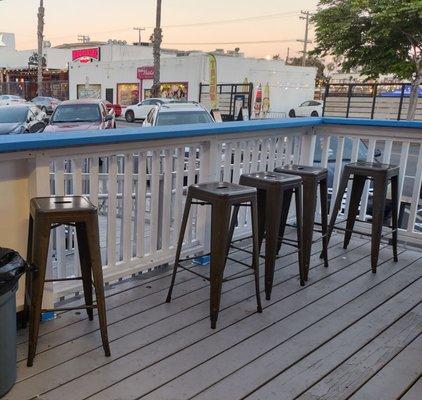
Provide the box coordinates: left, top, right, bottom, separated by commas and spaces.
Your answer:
86, 214, 110, 357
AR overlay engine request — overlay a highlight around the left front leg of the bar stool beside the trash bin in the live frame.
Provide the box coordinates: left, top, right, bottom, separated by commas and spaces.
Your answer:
27, 218, 50, 367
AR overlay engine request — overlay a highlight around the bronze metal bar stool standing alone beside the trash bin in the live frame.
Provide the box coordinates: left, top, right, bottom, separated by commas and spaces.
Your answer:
24, 196, 110, 367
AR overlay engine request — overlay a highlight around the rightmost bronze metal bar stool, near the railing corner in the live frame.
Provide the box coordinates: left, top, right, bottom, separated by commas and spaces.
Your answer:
328, 161, 400, 273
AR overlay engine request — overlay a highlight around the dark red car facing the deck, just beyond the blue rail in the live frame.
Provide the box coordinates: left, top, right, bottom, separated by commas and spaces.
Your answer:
44, 99, 116, 133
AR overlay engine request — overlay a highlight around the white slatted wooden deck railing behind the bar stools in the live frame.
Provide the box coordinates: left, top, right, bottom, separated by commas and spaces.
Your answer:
0, 119, 422, 304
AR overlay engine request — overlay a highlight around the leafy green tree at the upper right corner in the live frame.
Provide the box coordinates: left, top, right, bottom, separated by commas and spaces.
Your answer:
312, 0, 422, 119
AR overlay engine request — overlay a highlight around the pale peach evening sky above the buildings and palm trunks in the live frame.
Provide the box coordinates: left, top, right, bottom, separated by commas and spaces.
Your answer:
0, 0, 317, 59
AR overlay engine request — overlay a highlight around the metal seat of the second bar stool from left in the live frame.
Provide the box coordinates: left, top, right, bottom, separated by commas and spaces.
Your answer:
189, 182, 256, 201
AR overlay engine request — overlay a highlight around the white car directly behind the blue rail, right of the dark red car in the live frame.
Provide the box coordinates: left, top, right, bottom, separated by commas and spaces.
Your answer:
143, 102, 215, 126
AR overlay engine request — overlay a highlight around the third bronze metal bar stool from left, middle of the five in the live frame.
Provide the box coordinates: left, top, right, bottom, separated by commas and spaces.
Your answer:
239, 172, 305, 300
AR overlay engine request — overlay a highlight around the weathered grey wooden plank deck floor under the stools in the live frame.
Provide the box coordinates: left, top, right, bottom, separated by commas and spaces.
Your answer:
5, 231, 422, 400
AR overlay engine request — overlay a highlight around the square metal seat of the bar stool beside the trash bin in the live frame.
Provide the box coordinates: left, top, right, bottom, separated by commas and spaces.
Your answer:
31, 196, 97, 214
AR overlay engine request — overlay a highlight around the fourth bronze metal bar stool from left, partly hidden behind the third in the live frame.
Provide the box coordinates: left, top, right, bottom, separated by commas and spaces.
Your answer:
274, 164, 328, 281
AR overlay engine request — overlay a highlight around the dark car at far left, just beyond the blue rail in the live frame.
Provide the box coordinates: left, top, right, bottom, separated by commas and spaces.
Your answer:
0, 103, 47, 135
